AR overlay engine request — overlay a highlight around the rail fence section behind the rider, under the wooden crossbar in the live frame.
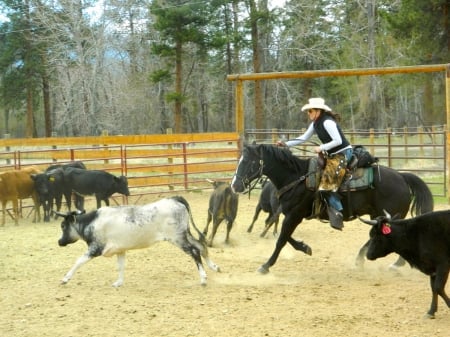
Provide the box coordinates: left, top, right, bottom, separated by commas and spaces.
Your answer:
244, 125, 447, 197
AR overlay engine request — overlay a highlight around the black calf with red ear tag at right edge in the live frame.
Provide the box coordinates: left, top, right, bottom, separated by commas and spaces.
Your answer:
361, 210, 450, 318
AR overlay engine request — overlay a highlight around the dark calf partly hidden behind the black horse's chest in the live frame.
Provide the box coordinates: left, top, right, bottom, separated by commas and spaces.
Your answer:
247, 180, 281, 237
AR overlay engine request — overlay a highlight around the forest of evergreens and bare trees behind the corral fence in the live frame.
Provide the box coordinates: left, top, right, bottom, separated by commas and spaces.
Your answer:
0, 0, 450, 138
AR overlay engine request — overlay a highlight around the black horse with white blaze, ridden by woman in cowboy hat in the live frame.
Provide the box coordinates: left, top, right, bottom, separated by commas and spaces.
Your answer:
231, 144, 433, 274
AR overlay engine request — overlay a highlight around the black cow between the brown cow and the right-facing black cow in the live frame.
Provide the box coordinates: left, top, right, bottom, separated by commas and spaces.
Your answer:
32, 161, 86, 221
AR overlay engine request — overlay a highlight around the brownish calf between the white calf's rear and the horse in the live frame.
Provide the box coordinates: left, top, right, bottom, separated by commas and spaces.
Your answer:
203, 180, 239, 247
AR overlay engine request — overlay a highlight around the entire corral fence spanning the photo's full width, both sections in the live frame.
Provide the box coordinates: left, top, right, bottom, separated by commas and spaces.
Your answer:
0, 126, 447, 219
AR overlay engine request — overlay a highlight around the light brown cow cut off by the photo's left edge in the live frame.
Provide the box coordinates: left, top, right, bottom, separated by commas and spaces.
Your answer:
0, 166, 41, 226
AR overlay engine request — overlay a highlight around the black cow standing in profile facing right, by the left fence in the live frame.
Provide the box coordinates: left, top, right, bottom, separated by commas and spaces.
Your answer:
64, 167, 130, 209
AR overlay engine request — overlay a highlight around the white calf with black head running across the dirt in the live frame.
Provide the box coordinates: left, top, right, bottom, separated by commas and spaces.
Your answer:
58, 197, 219, 287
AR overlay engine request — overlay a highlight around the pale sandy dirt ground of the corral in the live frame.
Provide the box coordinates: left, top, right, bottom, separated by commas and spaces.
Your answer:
0, 192, 450, 337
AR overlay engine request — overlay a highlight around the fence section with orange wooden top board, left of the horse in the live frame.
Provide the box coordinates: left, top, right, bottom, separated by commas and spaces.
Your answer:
0, 133, 240, 203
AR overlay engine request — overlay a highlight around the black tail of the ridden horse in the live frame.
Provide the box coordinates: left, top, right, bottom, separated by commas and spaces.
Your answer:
400, 172, 434, 216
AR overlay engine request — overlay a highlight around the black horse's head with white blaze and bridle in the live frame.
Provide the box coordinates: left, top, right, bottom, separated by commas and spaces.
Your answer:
231, 145, 263, 193
